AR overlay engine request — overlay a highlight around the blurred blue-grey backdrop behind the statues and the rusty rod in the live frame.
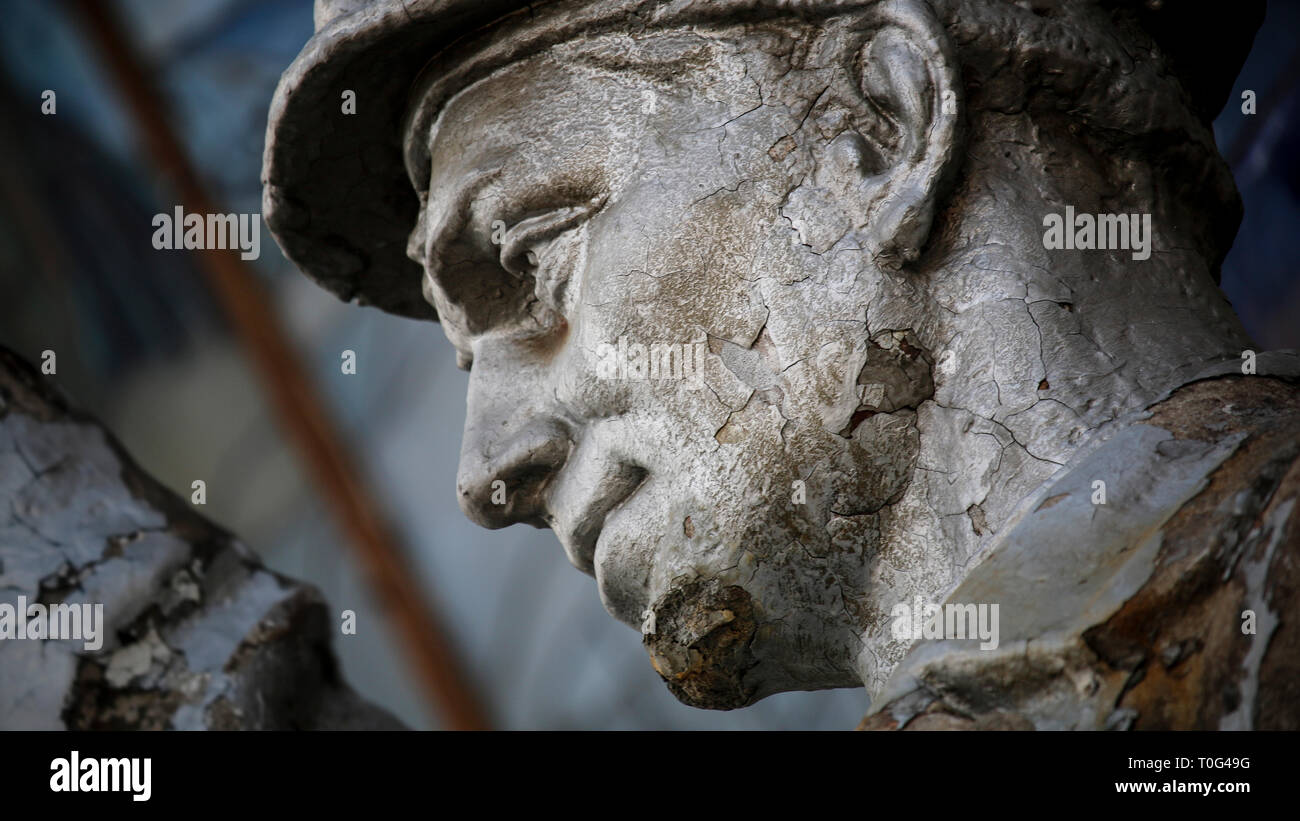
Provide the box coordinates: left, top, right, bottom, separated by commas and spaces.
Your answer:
0, 0, 1300, 729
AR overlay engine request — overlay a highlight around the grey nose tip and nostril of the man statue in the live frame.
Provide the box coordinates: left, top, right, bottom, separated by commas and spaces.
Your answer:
456, 420, 571, 529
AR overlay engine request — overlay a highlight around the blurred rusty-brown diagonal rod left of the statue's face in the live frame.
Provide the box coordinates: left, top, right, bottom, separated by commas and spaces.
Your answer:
73, 0, 488, 730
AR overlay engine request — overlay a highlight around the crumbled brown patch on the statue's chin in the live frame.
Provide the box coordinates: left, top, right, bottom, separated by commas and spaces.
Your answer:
644, 579, 761, 709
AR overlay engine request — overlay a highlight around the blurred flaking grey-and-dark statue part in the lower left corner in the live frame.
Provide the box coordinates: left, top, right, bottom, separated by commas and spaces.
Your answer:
0, 347, 403, 730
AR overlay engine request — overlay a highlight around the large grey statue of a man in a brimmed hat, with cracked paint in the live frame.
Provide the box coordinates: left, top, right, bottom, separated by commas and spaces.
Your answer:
264, 0, 1300, 729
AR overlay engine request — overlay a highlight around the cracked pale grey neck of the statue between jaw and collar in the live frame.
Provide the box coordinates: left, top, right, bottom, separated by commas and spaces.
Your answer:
859, 160, 1251, 692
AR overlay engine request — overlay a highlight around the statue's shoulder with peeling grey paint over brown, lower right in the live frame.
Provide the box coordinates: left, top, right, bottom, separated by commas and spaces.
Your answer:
862, 355, 1300, 729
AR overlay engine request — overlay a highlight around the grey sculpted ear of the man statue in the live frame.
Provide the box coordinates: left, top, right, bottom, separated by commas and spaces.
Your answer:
831, 0, 961, 268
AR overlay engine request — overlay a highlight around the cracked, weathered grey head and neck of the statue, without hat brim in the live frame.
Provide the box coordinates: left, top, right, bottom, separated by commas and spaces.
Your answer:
258, 0, 1284, 726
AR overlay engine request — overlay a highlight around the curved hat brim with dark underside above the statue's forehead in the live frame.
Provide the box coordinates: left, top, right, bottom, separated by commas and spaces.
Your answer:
261, 0, 528, 320
